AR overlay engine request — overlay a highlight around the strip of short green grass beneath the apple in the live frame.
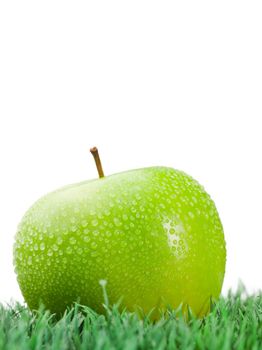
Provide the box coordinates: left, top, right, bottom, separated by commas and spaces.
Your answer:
0, 292, 262, 350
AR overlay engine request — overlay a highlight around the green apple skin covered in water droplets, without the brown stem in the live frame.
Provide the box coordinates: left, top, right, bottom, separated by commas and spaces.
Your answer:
14, 167, 226, 316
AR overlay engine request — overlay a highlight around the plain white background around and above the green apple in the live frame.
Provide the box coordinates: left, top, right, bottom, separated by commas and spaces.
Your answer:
0, 0, 262, 302
